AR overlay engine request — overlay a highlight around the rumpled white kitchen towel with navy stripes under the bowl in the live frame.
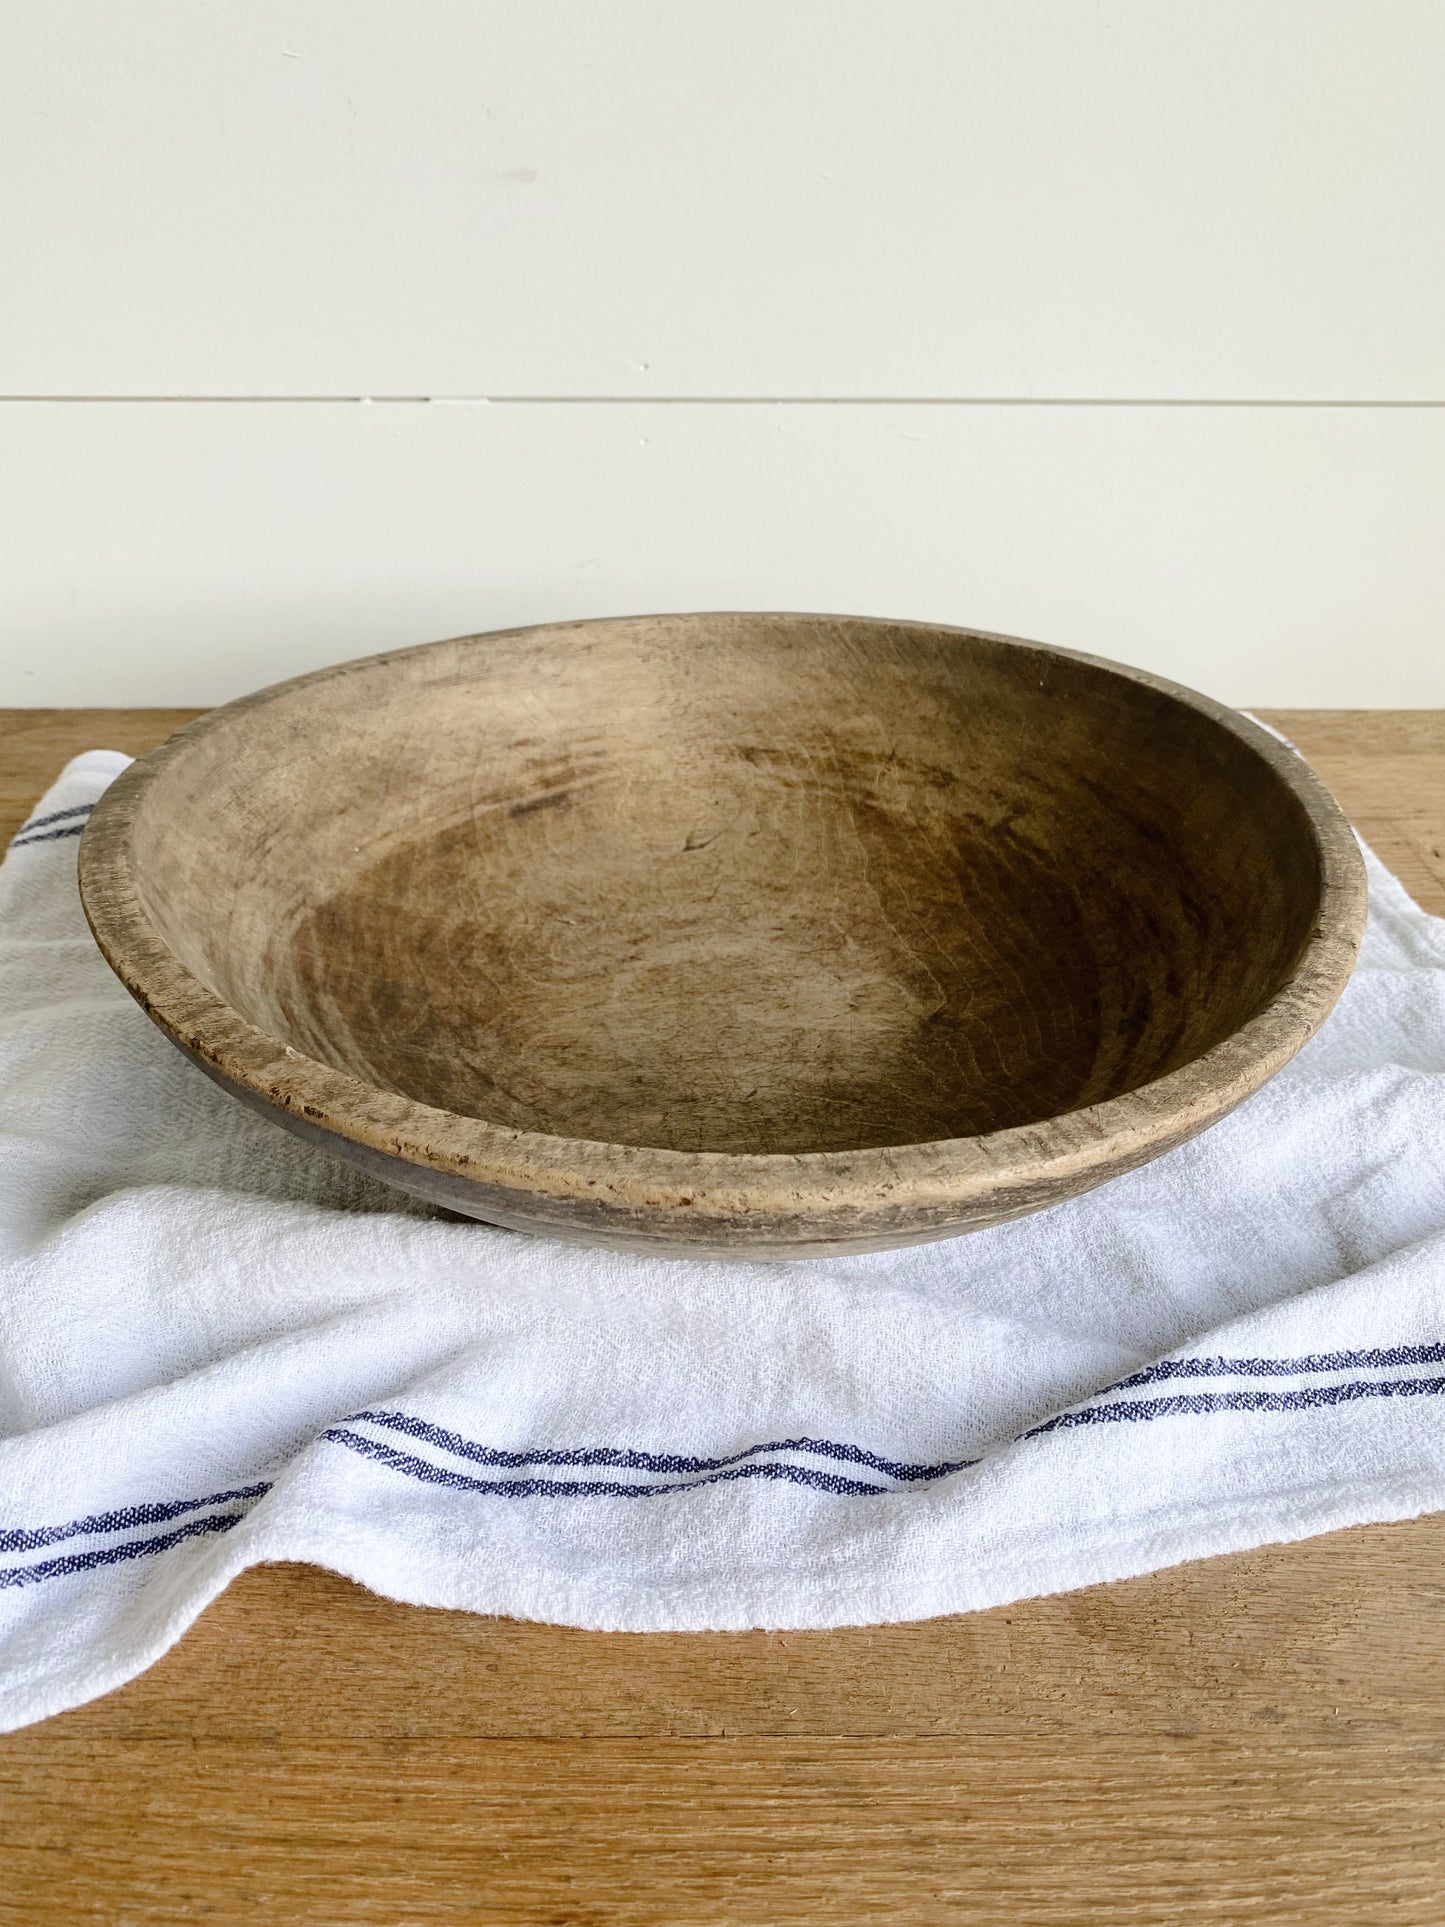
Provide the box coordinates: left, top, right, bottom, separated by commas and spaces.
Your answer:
0, 752, 1445, 1727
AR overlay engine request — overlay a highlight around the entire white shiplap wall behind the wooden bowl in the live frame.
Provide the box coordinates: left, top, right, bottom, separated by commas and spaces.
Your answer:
0, 0, 1445, 705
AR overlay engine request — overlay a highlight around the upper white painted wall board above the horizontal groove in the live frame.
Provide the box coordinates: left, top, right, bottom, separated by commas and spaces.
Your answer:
0, 0, 1445, 398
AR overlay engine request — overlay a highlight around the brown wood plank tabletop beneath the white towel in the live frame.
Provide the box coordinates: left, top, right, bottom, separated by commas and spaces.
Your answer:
0, 709, 1445, 1927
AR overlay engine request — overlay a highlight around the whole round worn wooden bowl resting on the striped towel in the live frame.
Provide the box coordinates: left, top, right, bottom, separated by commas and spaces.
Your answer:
81, 615, 1366, 1256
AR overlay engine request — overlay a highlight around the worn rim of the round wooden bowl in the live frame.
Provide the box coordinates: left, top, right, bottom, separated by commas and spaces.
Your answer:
79, 611, 1368, 1218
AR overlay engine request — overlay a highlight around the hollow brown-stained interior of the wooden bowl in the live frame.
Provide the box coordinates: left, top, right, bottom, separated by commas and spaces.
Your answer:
124, 617, 1320, 1152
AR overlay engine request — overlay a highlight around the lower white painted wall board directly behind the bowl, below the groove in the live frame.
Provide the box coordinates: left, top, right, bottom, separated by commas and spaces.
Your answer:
0, 403, 1445, 705
